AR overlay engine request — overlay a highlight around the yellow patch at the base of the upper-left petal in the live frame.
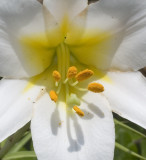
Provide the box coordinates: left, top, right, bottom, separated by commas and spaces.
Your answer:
18, 33, 55, 73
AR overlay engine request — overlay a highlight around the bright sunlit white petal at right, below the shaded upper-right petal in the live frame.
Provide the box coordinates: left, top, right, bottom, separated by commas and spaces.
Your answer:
104, 72, 146, 128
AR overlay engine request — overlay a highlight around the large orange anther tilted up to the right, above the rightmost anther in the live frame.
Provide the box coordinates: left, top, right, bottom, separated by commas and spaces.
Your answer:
75, 69, 94, 81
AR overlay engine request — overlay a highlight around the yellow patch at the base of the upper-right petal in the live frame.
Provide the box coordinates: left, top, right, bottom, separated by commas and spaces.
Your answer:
70, 28, 117, 81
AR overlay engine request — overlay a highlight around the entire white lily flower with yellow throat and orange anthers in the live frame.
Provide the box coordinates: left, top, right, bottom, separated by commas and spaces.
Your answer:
0, 0, 146, 160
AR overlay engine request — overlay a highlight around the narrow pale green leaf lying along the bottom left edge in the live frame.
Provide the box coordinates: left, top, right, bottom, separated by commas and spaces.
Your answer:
2, 151, 36, 160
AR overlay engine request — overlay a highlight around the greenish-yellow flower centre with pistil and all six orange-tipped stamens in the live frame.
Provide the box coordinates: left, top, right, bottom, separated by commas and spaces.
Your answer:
49, 43, 104, 116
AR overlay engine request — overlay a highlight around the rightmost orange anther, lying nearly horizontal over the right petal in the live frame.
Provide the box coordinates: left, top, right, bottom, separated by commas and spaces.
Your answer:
88, 82, 104, 93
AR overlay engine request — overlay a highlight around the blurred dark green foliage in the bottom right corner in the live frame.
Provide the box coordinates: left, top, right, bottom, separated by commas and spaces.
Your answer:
114, 114, 146, 160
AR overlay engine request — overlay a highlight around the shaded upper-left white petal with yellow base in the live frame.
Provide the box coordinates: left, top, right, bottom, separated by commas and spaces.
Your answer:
0, 0, 53, 78
